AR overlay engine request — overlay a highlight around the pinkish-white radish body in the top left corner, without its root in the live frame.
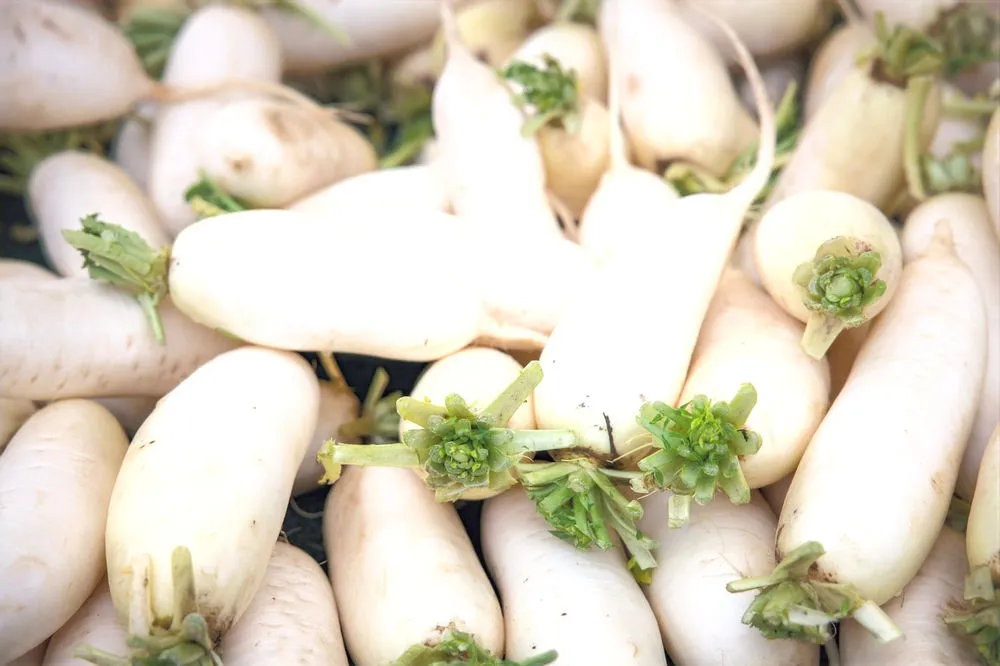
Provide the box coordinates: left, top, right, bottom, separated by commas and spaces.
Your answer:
0, 0, 155, 132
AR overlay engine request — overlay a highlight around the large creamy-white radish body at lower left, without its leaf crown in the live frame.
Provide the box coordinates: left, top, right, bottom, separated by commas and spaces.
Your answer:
106, 347, 319, 640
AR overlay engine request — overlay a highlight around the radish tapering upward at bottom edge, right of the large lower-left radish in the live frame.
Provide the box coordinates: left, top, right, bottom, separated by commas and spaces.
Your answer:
219, 541, 348, 666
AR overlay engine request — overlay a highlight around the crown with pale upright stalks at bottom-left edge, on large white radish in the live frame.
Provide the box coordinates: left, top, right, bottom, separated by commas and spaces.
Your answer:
73, 546, 222, 666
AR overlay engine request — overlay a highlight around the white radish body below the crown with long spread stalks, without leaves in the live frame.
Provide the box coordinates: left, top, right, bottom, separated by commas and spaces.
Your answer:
323, 467, 504, 666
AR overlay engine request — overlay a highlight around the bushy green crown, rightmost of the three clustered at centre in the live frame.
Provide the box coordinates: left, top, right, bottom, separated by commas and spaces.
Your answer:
632, 384, 761, 527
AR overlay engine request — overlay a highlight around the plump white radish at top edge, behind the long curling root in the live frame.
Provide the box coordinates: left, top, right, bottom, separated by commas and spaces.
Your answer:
598, 0, 757, 174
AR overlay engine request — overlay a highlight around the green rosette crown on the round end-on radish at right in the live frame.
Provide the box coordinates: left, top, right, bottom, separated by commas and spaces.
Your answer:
792, 236, 886, 359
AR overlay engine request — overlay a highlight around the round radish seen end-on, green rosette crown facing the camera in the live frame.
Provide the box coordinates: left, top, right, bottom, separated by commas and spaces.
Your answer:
752, 190, 903, 358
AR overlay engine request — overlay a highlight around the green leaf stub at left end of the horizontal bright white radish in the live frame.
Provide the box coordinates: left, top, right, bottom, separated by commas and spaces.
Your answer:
62, 214, 170, 344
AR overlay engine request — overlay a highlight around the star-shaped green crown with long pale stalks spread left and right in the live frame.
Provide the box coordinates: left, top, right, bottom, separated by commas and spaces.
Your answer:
317, 361, 576, 502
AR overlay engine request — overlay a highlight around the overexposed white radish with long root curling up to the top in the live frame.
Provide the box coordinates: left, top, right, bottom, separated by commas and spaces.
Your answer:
535, 3, 775, 458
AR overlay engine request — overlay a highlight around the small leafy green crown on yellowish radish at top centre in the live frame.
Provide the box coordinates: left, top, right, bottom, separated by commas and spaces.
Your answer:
500, 54, 581, 136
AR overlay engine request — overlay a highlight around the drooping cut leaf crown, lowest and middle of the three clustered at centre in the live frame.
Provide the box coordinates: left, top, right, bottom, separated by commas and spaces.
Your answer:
517, 456, 656, 571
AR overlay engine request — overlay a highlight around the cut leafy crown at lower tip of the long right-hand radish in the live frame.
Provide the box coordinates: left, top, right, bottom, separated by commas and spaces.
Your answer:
726, 541, 902, 644
